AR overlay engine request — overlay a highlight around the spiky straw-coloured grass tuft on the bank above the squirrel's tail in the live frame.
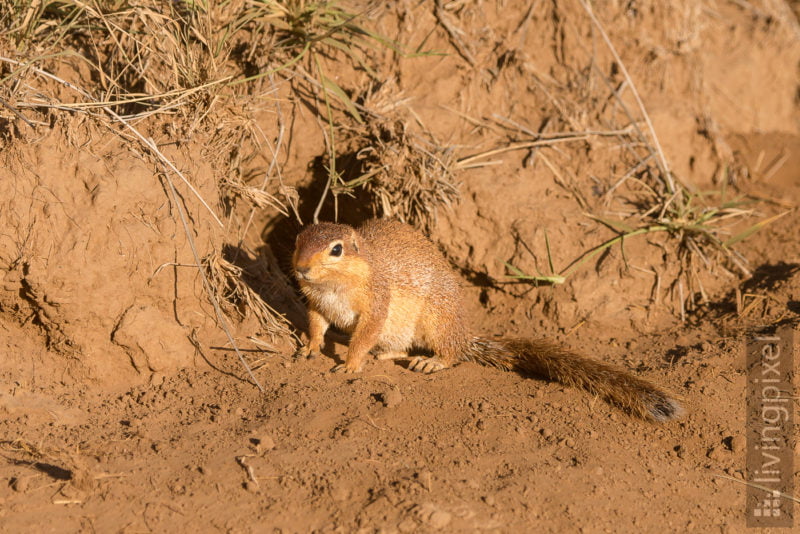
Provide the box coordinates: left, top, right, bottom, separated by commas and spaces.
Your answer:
496, 0, 789, 319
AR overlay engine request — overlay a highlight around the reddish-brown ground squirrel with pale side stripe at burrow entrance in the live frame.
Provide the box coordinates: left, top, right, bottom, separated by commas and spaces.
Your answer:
292, 219, 682, 421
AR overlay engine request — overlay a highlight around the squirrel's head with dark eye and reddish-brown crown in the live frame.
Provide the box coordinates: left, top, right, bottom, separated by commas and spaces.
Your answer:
292, 223, 360, 284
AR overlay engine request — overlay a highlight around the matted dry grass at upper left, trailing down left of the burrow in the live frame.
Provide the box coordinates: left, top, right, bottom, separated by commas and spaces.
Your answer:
0, 0, 410, 384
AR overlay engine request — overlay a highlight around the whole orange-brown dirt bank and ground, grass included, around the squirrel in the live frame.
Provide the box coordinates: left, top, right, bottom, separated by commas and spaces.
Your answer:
0, 0, 800, 532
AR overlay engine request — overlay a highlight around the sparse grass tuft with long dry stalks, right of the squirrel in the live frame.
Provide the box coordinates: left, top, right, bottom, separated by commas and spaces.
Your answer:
500, 0, 792, 317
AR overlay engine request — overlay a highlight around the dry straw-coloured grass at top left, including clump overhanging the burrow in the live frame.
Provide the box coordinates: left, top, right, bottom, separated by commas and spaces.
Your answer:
0, 0, 456, 237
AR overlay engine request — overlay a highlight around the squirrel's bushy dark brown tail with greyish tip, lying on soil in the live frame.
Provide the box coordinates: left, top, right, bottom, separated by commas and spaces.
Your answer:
465, 337, 683, 421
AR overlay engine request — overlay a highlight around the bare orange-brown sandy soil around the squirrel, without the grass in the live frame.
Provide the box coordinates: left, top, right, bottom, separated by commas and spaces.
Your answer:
0, 0, 800, 533
